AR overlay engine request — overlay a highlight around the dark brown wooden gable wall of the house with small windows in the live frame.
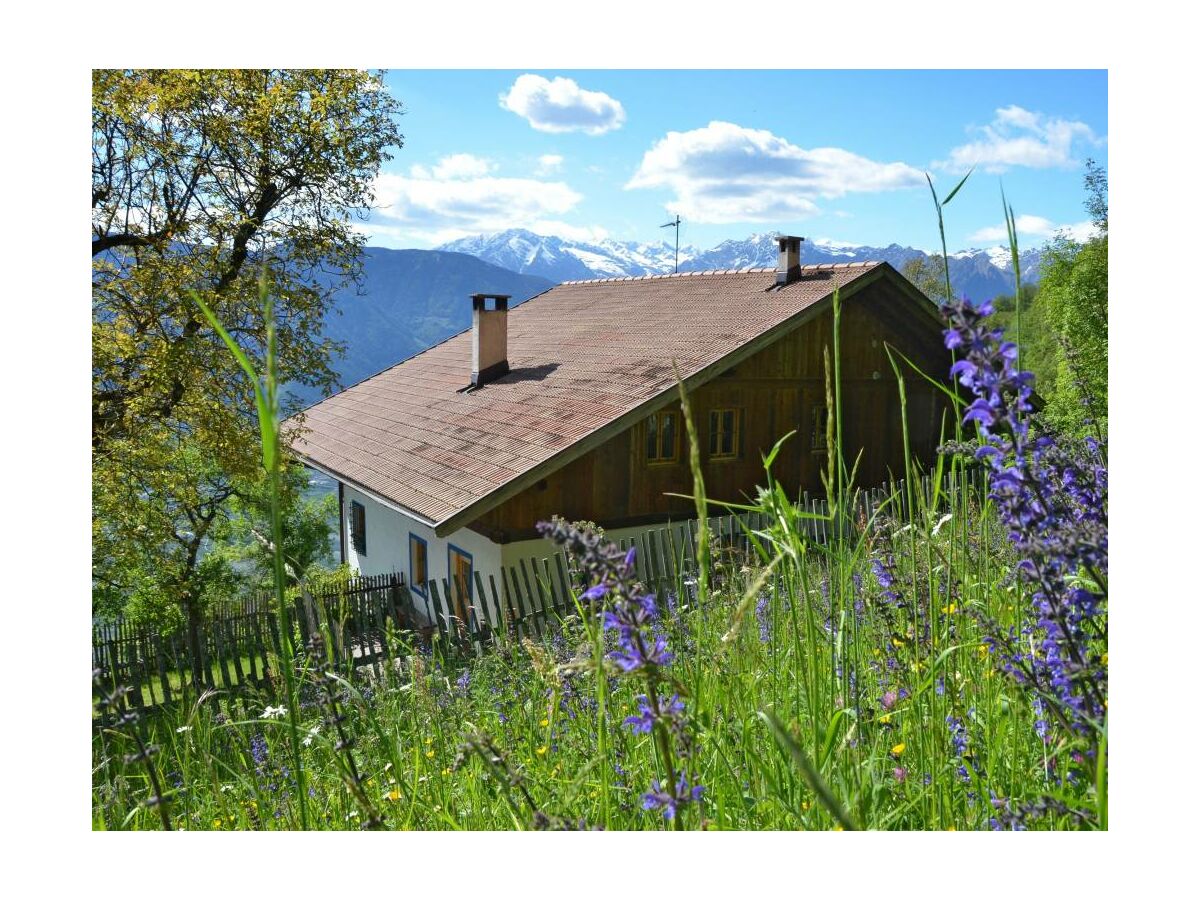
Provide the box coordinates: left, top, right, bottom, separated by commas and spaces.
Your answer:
469, 278, 953, 544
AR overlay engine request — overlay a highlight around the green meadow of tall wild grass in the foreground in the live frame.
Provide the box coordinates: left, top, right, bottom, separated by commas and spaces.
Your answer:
92, 195, 1108, 830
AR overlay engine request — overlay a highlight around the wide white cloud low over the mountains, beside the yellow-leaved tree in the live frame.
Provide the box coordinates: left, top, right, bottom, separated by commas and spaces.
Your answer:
362, 154, 583, 244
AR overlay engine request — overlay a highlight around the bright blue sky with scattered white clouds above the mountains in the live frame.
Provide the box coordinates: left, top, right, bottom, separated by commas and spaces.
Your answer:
367, 70, 1108, 252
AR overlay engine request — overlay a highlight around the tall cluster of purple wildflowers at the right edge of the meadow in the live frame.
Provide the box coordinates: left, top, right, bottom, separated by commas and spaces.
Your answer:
944, 301, 1108, 742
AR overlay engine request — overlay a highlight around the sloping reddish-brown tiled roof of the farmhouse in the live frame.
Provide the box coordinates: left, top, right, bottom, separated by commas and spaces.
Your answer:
293, 263, 887, 523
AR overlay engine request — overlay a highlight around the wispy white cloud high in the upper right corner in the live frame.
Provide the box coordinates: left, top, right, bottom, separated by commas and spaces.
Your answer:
934, 106, 1104, 173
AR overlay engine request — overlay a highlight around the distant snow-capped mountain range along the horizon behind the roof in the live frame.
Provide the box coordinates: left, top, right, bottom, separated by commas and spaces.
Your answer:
438, 228, 1040, 300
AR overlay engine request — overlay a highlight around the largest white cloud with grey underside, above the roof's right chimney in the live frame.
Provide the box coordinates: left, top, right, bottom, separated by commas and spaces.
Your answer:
625, 121, 925, 223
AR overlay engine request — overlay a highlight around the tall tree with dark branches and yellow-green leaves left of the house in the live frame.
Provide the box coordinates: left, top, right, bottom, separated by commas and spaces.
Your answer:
92, 70, 403, 648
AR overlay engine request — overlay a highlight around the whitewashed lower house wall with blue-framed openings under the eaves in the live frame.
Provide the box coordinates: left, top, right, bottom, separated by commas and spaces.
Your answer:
342, 485, 502, 628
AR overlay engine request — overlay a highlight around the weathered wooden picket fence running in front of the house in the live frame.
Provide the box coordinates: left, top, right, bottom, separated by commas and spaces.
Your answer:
92, 478, 982, 720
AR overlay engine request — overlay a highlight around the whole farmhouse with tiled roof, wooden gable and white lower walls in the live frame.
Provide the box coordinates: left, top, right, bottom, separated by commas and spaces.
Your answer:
293, 238, 950, 624
